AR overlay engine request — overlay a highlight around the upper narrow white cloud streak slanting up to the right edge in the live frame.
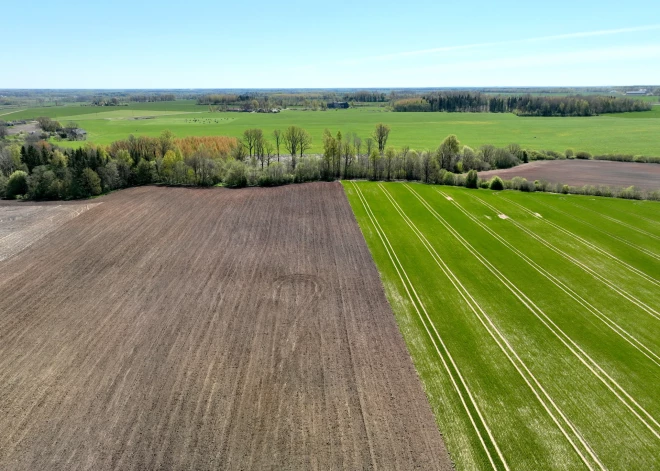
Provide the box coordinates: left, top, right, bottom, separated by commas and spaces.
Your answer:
342, 24, 660, 64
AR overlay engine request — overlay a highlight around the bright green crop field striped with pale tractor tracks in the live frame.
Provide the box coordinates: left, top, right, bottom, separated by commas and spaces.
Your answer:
344, 182, 660, 470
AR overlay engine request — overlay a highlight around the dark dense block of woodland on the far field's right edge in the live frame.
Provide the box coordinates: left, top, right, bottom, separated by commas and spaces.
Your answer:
392, 92, 652, 116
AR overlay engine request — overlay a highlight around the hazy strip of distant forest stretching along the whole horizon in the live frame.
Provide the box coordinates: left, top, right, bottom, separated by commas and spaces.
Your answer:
0, 85, 660, 116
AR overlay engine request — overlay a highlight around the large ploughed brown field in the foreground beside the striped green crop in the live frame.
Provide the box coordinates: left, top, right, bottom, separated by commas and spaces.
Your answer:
0, 183, 450, 470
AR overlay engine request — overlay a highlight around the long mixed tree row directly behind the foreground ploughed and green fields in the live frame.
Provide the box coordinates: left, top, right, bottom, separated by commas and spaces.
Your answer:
0, 123, 660, 199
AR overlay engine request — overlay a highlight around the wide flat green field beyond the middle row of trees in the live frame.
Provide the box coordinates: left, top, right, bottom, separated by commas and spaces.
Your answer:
0, 101, 660, 156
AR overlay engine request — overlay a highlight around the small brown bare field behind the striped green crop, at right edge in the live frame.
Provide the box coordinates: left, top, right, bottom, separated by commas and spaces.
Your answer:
479, 160, 660, 190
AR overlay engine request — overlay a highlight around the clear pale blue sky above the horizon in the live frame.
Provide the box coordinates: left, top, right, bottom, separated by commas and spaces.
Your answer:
5, 0, 660, 89
